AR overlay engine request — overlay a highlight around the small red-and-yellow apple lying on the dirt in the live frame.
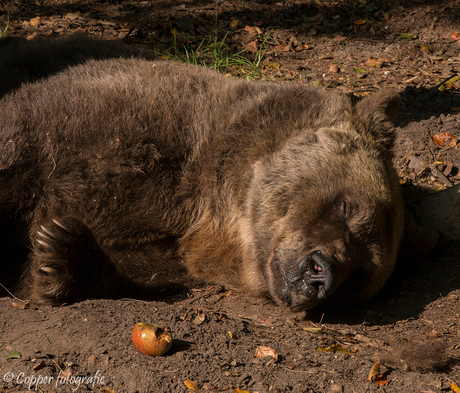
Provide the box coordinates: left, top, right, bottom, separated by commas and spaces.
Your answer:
131, 322, 172, 356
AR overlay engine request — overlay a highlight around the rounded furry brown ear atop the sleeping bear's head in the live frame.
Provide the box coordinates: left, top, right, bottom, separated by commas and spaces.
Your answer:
353, 90, 401, 150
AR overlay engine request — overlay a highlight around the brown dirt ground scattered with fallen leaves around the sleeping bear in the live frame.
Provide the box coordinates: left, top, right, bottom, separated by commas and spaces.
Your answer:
0, 0, 460, 393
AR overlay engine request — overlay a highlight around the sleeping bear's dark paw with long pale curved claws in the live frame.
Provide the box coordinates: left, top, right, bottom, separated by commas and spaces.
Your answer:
22, 217, 120, 306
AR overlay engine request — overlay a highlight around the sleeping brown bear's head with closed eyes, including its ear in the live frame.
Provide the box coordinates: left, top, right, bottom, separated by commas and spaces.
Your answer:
242, 93, 403, 311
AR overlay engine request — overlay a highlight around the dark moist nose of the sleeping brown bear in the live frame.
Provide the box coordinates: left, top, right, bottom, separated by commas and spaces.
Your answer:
299, 250, 335, 299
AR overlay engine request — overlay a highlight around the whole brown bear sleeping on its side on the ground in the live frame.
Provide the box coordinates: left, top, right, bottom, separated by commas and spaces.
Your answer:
0, 46, 403, 311
